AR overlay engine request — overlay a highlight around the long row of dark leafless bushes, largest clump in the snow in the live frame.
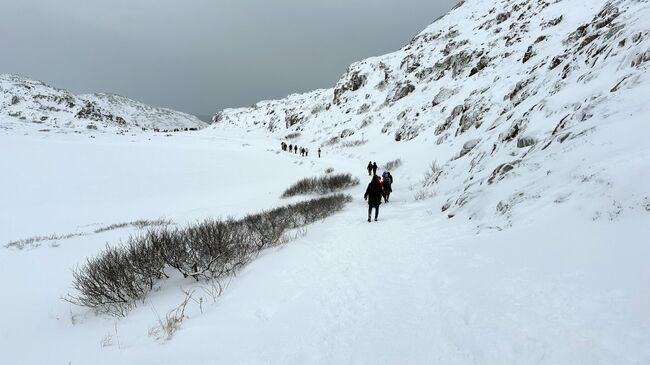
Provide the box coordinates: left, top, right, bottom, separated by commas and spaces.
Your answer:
66, 193, 350, 316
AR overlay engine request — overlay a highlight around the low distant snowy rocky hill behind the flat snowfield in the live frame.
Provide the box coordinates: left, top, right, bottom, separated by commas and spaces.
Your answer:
0, 75, 206, 130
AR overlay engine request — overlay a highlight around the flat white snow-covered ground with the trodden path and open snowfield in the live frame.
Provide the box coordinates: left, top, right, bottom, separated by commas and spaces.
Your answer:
0, 126, 650, 364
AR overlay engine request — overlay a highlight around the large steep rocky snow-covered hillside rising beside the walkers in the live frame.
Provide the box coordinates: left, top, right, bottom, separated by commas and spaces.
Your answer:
212, 0, 650, 229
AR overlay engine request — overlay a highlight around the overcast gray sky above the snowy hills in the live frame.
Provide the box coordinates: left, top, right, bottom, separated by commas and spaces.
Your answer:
0, 0, 459, 115
